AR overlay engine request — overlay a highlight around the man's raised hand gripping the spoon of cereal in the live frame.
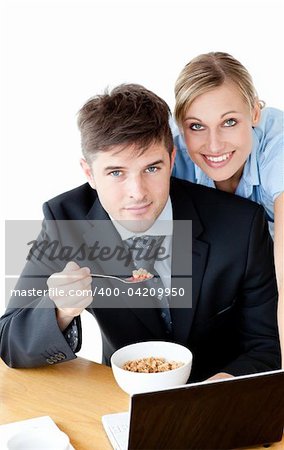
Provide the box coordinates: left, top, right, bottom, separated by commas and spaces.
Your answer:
47, 261, 93, 330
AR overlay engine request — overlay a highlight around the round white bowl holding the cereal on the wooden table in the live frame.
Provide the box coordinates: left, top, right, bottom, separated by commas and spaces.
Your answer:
110, 341, 192, 395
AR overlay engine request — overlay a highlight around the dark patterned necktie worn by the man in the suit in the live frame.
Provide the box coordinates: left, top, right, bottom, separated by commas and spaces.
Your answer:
124, 235, 172, 335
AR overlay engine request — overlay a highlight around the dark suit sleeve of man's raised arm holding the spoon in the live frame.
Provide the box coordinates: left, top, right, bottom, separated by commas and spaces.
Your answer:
0, 204, 81, 367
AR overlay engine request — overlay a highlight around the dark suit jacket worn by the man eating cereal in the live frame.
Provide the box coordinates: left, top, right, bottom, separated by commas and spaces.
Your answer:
0, 178, 280, 381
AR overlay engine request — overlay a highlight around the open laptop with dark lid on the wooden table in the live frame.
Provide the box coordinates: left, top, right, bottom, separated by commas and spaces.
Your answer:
102, 370, 284, 450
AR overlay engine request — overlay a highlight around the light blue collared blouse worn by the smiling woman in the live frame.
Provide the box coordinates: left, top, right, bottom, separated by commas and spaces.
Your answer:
171, 108, 284, 236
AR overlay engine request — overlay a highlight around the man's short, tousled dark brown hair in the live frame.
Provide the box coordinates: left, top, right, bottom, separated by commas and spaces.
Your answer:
78, 84, 174, 161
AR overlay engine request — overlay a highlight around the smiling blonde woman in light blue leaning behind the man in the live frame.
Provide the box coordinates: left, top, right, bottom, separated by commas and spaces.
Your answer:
173, 52, 284, 362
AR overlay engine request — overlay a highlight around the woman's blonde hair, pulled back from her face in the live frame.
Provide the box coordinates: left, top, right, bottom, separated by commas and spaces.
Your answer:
174, 52, 265, 125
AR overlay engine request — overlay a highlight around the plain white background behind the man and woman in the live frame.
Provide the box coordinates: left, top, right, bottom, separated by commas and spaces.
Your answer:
0, 0, 284, 359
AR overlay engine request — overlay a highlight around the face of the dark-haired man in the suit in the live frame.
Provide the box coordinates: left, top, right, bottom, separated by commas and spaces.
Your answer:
81, 143, 174, 231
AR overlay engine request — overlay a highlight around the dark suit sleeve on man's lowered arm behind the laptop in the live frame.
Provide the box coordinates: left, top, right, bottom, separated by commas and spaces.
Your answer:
223, 208, 281, 376
